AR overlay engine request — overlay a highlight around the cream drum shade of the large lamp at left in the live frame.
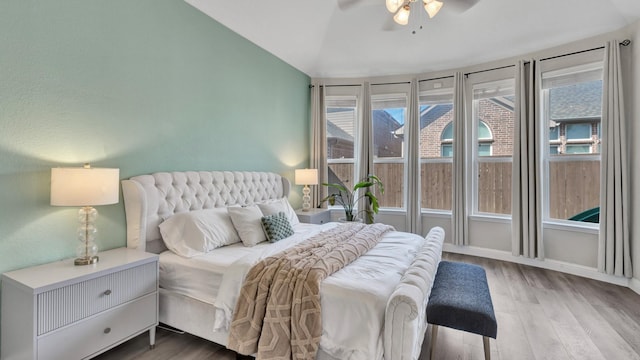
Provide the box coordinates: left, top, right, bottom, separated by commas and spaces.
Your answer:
51, 167, 120, 206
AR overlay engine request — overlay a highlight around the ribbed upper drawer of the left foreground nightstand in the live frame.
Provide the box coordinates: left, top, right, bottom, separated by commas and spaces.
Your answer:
37, 262, 158, 335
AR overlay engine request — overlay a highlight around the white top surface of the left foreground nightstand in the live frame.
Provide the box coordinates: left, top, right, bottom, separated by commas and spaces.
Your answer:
2, 247, 158, 293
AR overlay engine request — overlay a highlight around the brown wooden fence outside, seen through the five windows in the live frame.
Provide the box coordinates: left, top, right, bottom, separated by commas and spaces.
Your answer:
329, 160, 600, 219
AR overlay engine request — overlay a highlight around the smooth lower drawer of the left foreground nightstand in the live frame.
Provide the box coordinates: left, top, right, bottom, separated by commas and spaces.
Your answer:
38, 293, 158, 360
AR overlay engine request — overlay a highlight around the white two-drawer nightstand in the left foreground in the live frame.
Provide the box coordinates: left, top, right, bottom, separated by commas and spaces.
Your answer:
0, 248, 158, 359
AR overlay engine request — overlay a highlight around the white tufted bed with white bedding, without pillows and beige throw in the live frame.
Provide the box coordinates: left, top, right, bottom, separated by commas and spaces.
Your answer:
122, 171, 444, 360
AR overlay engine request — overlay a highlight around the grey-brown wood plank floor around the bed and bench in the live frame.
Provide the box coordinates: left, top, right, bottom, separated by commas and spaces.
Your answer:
96, 254, 640, 360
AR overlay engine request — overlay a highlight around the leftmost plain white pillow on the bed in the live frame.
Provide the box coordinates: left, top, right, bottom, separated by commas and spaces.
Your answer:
160, 208, 240, 257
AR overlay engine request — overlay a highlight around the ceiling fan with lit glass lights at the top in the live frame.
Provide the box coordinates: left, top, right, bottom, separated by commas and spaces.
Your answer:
338, 0, 479, 25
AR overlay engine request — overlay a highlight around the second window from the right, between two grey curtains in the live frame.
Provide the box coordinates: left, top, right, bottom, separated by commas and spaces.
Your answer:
471, 79, 515, 216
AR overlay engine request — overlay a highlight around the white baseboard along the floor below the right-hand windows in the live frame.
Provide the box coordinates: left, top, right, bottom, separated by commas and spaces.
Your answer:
442, 243, 640, 288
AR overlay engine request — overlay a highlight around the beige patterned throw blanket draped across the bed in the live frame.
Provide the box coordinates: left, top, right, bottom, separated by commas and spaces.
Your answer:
227, 223, 393, 360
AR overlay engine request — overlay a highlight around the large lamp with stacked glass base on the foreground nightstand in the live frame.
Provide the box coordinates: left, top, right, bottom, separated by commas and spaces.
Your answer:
51, 164, 120, 265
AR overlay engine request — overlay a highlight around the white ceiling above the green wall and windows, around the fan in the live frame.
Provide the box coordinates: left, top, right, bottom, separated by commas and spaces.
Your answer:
185, 0, 640, 78
